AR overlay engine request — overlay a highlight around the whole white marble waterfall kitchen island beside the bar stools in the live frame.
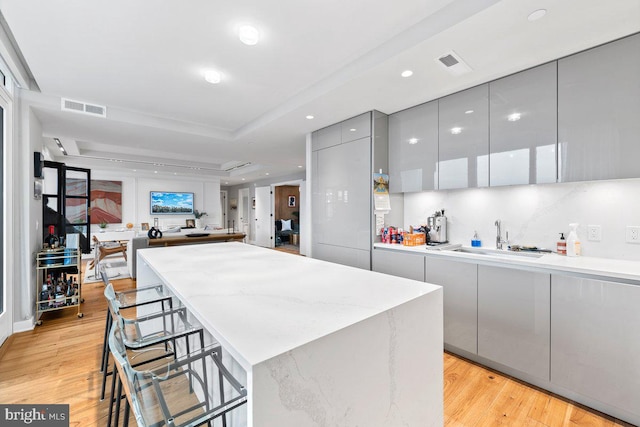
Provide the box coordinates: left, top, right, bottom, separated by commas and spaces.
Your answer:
138, 242, 443, 427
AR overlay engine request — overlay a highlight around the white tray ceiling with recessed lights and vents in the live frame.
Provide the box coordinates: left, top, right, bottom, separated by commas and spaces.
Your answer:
0, 0, 640, 185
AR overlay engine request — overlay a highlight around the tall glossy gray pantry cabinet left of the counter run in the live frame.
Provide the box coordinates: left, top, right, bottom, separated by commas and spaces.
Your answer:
311, 111, 388, 270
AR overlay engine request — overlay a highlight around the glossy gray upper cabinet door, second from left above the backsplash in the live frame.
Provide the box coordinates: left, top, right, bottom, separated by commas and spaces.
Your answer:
438, 84, 489, 190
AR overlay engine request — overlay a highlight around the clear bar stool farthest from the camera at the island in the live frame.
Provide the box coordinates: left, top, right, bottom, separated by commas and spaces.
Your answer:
100, 266, 173, 400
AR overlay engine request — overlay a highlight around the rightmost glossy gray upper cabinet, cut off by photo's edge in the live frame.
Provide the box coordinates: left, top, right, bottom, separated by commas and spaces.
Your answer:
558, 34, 640, 182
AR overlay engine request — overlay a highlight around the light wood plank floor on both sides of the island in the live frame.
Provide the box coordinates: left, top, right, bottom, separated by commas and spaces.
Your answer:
0, 272, 629, 427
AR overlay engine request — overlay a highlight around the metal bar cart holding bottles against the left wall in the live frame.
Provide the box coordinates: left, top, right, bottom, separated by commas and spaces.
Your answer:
36, 248, 84, 325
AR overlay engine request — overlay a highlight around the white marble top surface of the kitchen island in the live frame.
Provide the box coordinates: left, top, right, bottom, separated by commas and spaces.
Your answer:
138, 243, 440, 370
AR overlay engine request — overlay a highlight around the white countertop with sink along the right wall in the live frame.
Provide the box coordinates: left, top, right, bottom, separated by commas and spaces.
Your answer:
374, 243, 640, 282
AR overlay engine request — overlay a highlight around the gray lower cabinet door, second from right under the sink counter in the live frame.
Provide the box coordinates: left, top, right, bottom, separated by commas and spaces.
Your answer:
478, 265, 551, 381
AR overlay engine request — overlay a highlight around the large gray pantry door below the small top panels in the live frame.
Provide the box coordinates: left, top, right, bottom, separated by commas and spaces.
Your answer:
312, 137, 372, 251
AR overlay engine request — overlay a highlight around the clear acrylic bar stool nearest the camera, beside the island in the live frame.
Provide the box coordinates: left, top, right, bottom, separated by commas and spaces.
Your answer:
109, 298, 247, 427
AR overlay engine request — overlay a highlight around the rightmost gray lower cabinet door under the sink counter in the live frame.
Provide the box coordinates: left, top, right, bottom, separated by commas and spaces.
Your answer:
551, 275, 640, 423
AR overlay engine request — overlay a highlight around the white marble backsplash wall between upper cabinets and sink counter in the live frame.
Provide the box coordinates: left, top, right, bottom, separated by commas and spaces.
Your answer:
402, 179, 640, 260
